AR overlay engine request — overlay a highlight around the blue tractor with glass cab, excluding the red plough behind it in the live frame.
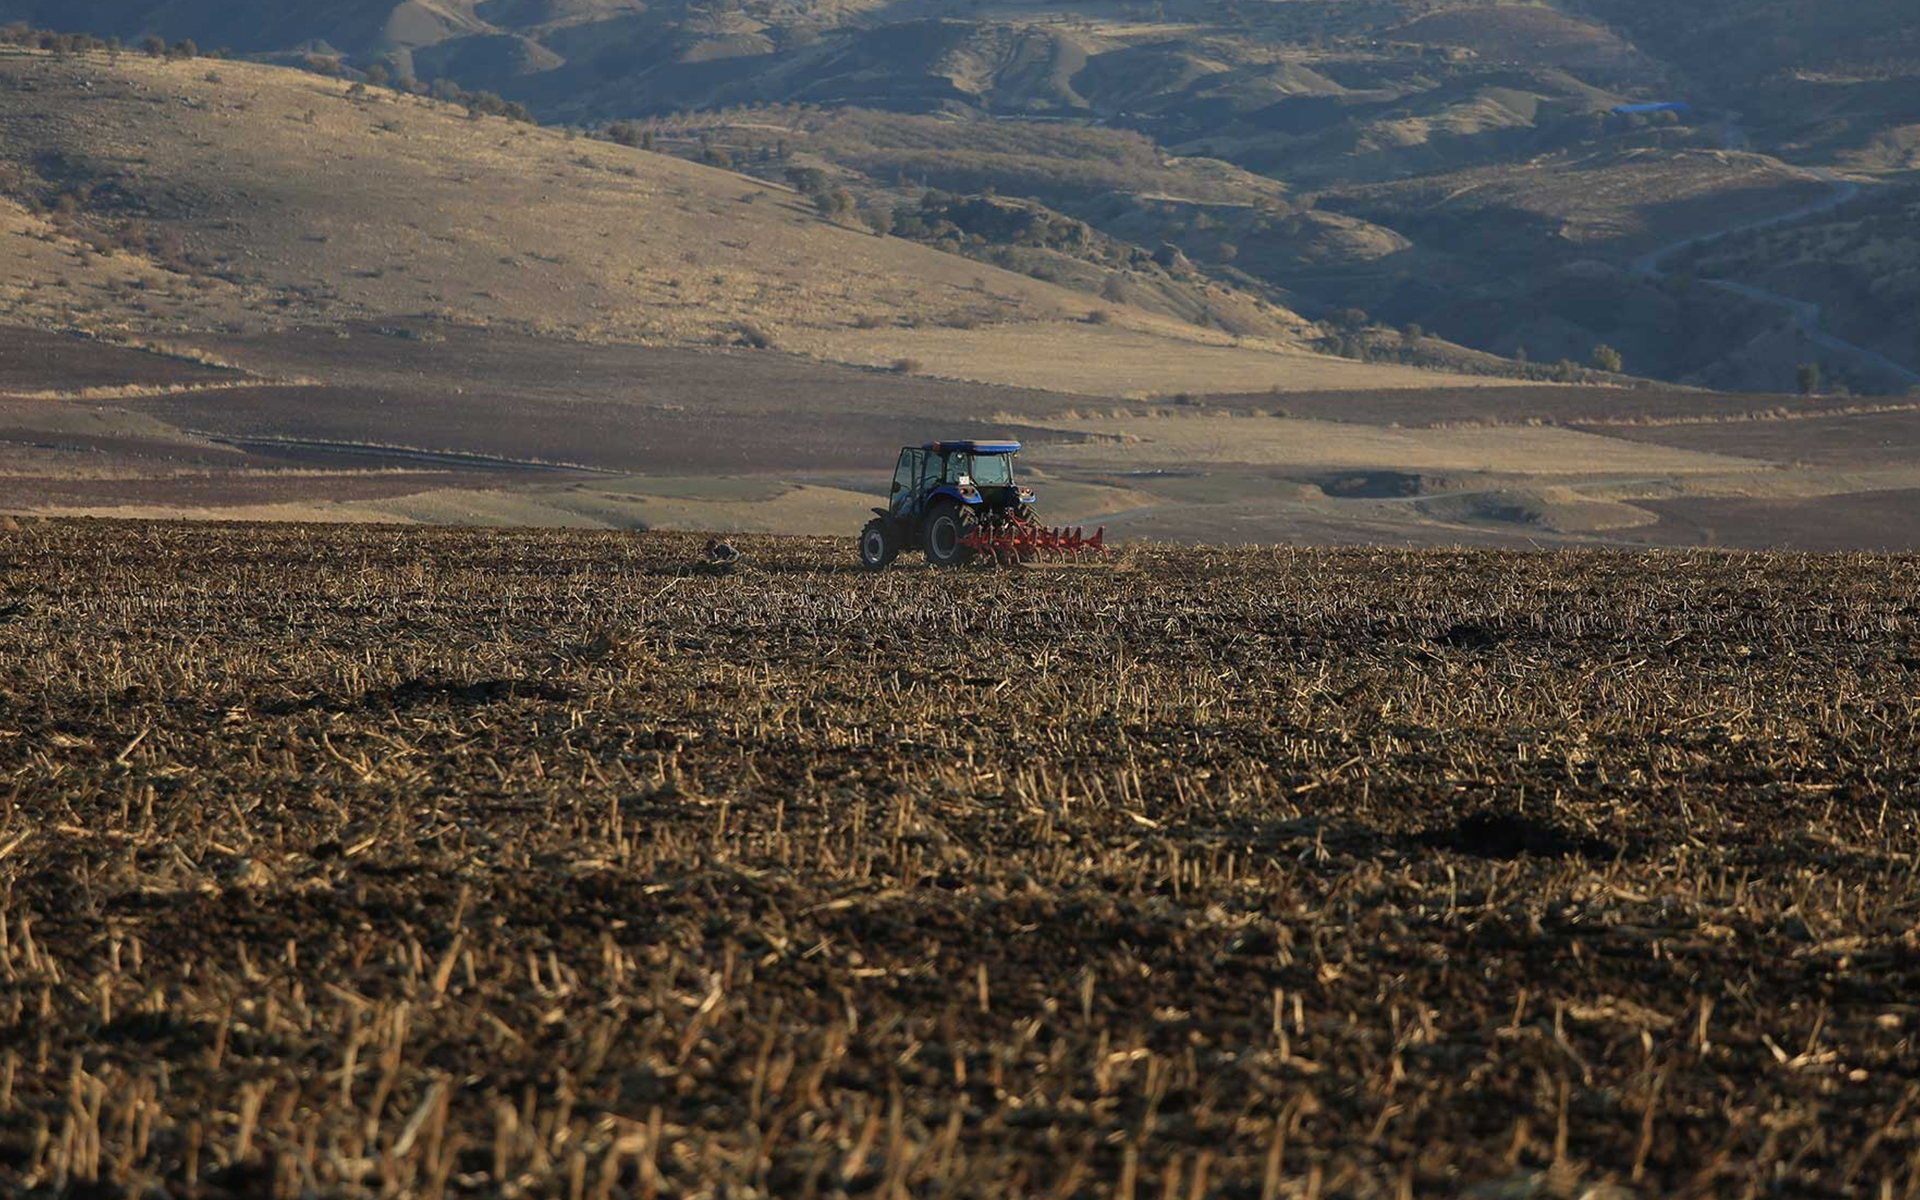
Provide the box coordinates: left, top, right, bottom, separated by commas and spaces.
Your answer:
860, 442, 1039, 570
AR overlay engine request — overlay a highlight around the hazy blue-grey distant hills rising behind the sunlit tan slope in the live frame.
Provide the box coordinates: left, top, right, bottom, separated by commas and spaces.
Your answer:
15, 0, 1920, 386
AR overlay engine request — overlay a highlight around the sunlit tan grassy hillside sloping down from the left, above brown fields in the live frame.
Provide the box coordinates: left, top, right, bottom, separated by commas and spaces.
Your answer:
0, 52, 1474, 394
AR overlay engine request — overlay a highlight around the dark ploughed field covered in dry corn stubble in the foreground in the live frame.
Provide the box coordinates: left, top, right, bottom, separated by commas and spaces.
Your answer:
0, 522, 1920, 1200
